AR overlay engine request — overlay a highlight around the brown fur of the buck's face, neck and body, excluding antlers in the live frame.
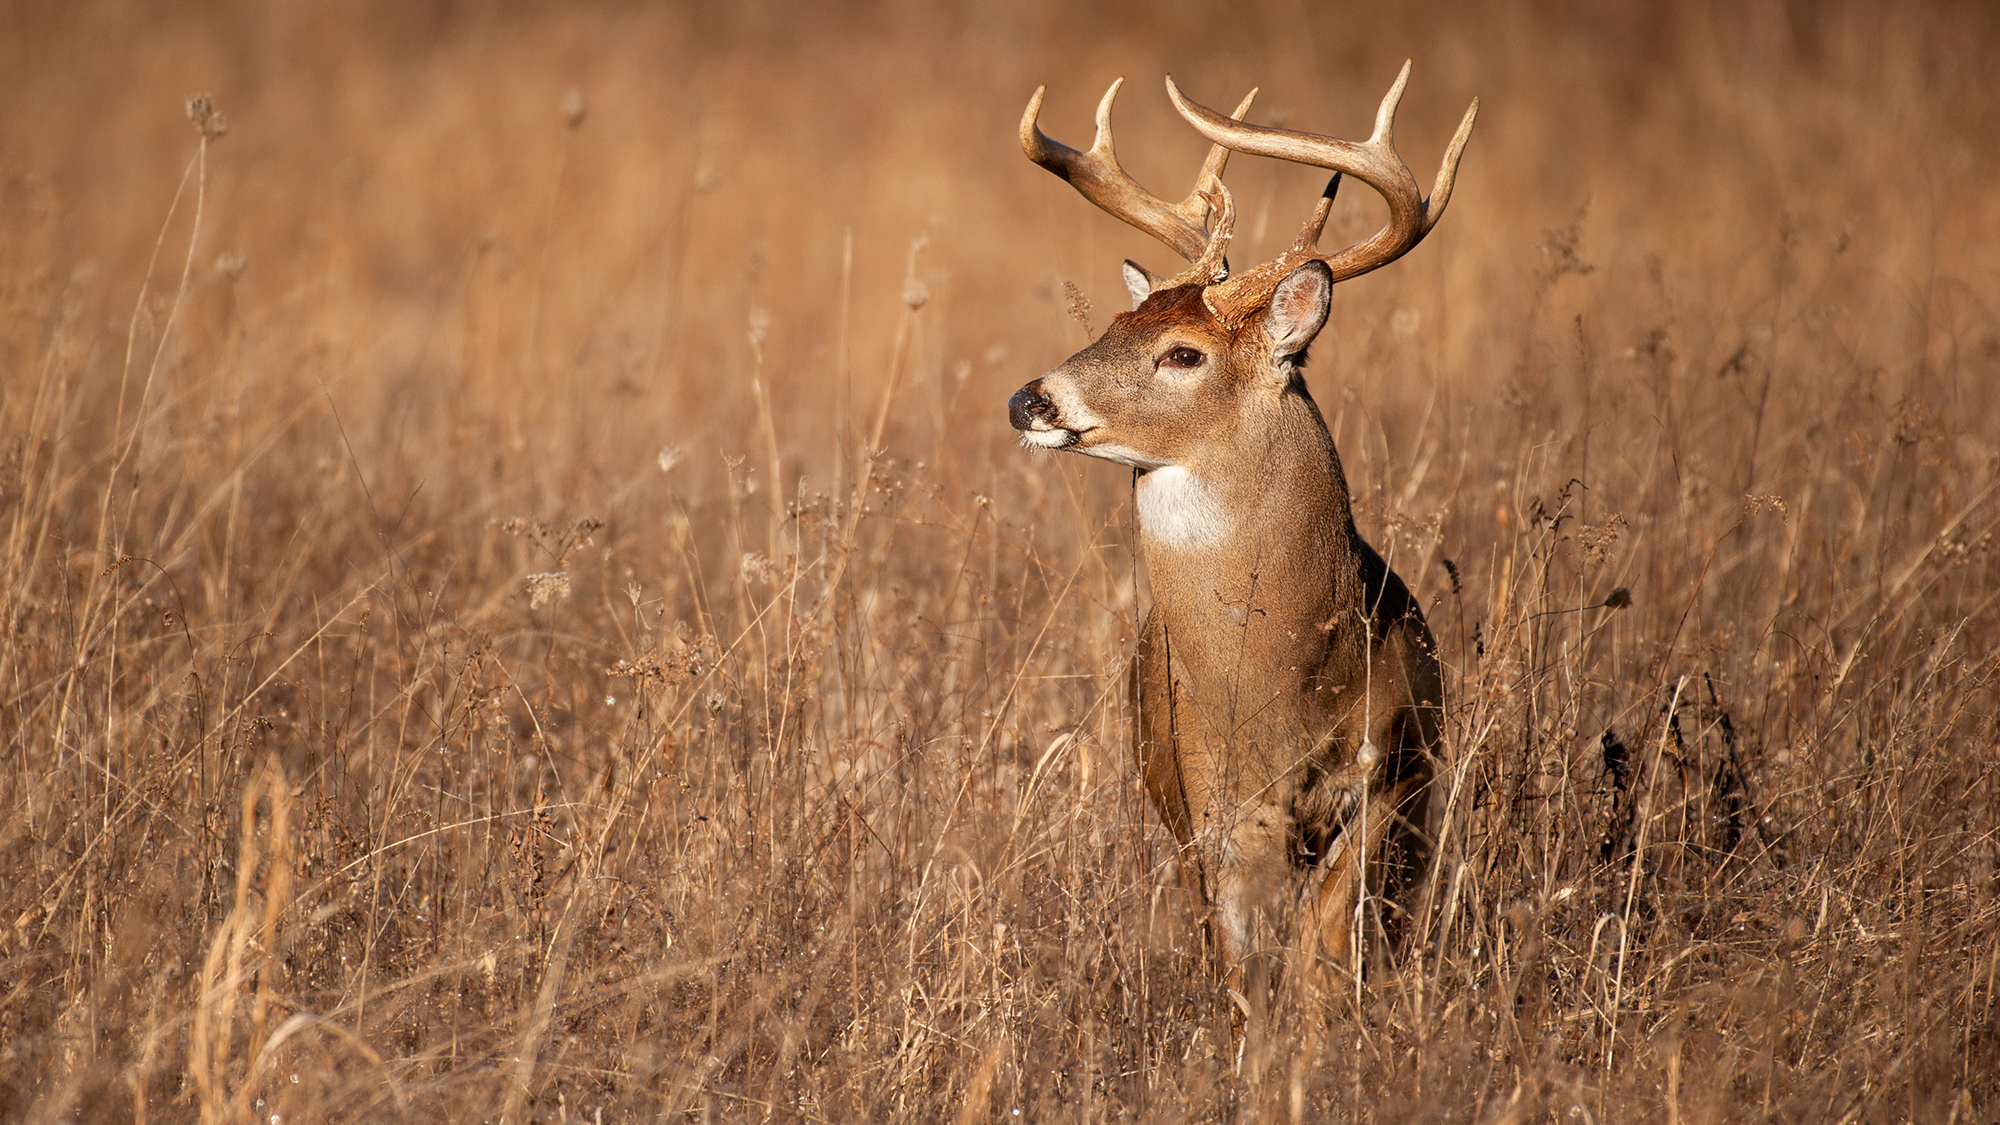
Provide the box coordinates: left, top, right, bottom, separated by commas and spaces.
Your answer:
1008, 266, 1444, 1003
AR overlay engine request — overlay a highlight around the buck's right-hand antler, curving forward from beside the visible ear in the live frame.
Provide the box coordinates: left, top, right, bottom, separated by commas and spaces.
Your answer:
1166, 62, 1480, 308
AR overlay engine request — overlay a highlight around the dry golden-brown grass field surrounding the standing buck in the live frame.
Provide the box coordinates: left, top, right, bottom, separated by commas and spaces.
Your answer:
0, 0, 2000, 1125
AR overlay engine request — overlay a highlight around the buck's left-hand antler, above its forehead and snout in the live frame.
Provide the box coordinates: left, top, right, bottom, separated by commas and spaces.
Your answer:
1020, 78, 1256, 266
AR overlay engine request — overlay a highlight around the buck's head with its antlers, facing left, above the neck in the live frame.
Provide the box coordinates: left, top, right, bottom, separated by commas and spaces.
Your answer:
1008, 62, 1478, 482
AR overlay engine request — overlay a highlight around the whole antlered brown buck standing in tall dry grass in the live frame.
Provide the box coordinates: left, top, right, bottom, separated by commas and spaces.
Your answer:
1008, 62, 1478, 1000
